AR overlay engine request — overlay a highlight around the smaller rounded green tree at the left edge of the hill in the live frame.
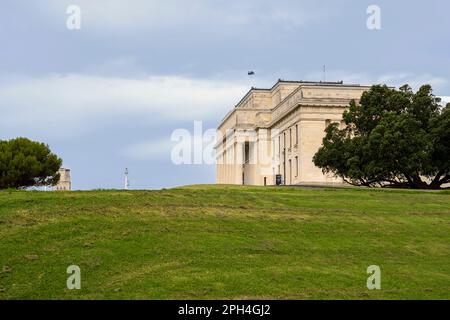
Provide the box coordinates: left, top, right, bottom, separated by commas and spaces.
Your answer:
0, 138, 62, 189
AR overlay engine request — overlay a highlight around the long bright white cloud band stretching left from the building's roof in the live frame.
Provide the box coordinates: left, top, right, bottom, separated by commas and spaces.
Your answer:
0, 74, 248, 137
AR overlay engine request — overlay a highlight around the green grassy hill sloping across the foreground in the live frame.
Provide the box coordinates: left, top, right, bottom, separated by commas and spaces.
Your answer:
0, 186, 450, 299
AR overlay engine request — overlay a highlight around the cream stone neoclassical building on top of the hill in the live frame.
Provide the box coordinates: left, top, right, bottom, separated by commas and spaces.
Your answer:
216, 80, 370, 186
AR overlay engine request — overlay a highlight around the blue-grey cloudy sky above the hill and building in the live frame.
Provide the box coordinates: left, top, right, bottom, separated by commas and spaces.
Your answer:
0, 0, 450, 189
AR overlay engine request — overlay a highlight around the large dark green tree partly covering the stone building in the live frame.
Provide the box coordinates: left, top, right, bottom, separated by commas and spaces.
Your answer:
313, 85, 450, 189
